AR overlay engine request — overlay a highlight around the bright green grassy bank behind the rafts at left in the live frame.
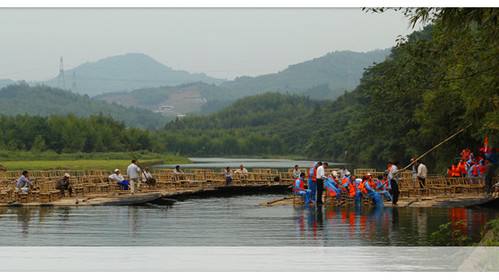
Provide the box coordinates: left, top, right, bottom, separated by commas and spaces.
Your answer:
0, 151, 189, 170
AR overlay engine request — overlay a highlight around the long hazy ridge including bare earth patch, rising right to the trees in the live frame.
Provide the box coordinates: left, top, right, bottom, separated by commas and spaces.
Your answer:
95, 49, 390, 116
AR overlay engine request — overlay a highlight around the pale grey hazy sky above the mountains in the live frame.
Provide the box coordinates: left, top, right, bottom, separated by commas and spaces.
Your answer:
0, 8, 411, 80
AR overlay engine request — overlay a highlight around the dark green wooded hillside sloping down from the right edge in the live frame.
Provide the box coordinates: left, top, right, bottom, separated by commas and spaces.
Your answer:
162, 9, 499, 171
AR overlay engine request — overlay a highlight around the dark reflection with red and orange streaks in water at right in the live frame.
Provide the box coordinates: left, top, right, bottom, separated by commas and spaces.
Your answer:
294, 205, 497, 245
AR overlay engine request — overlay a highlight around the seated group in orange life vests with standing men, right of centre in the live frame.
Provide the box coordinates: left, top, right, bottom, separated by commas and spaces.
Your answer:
292, 161, 399, 206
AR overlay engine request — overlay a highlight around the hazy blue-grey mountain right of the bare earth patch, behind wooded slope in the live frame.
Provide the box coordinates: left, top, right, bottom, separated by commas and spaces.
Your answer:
221, 49, 390, 99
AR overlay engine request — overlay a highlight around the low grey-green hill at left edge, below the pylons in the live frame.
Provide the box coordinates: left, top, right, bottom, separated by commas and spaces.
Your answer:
0, 83, 168, 129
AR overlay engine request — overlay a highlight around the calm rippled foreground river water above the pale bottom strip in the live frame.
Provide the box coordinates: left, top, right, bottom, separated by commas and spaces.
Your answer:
0, 195, 498, 247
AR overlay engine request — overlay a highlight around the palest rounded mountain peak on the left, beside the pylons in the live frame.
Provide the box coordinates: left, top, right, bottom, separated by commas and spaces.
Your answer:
42, 53, 223, 96
